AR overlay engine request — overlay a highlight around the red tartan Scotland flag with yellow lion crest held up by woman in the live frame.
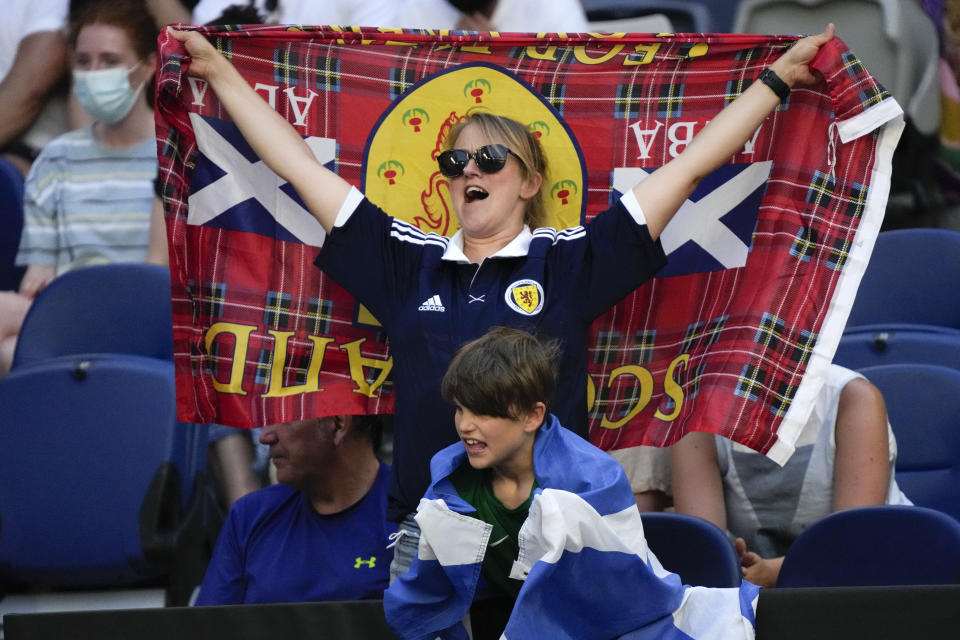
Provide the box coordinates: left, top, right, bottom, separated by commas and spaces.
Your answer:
157, 25, 902, 461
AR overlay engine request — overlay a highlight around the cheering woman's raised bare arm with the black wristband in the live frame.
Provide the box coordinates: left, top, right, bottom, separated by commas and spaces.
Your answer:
633, 24, 834, 238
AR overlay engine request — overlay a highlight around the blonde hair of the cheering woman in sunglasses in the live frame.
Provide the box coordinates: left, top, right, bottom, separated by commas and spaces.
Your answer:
444, 110, 547, 229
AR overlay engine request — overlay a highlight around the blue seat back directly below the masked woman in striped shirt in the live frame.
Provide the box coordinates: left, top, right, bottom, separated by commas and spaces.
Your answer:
12, 263, 173, 369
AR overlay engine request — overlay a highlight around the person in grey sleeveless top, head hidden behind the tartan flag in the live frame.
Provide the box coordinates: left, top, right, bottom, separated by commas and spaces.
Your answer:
672, 365, 911, 587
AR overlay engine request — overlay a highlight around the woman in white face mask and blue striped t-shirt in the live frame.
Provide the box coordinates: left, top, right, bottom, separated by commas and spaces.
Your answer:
0, 0, 157, 375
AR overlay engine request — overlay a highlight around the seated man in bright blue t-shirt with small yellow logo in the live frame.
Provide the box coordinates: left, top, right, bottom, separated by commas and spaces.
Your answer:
196, 416, 396, 605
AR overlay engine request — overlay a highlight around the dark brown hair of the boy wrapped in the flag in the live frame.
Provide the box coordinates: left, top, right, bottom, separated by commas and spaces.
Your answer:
440, 327, 558, 420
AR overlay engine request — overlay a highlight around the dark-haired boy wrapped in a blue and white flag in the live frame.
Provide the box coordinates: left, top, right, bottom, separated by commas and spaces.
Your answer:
384, 327, 758, 640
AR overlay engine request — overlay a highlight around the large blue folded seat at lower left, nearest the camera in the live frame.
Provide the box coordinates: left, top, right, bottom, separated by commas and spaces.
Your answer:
0, 355, 215, 604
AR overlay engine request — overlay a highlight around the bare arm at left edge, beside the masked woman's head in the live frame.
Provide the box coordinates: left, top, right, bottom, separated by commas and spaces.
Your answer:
0, 31, 67, 147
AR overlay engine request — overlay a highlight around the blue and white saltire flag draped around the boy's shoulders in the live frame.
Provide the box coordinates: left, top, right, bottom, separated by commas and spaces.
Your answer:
383, 415, 760, 640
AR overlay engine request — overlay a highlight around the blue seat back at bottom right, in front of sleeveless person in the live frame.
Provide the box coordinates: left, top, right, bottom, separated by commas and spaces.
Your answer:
777, 505, 960, 587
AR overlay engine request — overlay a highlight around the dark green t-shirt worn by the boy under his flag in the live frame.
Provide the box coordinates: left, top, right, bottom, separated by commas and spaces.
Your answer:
450, 462, 537, 600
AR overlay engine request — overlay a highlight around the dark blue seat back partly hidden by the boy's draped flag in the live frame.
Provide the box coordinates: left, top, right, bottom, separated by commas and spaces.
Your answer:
640, 512, 742, 587
